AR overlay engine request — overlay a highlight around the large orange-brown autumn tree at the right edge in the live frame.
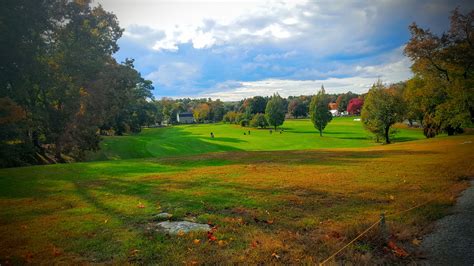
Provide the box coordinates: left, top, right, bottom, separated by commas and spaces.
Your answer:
404, 9, 474, 137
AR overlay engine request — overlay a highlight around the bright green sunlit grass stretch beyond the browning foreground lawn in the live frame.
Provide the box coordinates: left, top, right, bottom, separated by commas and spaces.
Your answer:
89, 117, 424, 160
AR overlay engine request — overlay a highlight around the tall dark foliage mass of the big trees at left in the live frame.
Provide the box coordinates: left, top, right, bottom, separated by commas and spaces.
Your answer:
0, 0, 153, 165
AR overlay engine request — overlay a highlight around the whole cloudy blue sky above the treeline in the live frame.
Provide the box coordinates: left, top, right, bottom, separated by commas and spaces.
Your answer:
95, 0, 474, 101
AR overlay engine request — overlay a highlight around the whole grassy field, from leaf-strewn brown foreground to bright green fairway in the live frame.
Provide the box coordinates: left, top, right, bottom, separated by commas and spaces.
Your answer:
0, 119, 474, 265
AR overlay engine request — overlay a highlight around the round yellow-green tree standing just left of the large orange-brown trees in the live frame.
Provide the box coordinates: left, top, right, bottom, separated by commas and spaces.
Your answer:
361, 80, 405, 144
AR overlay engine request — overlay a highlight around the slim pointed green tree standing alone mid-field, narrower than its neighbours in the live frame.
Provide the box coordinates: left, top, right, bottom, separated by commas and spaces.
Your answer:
309, 86, 332, 137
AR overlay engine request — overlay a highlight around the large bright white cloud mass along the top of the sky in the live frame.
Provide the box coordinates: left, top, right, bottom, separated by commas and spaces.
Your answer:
97, 0, 470, 56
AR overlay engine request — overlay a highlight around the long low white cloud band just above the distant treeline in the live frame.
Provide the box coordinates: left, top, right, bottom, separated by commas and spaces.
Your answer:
196, 48, 412, 101
